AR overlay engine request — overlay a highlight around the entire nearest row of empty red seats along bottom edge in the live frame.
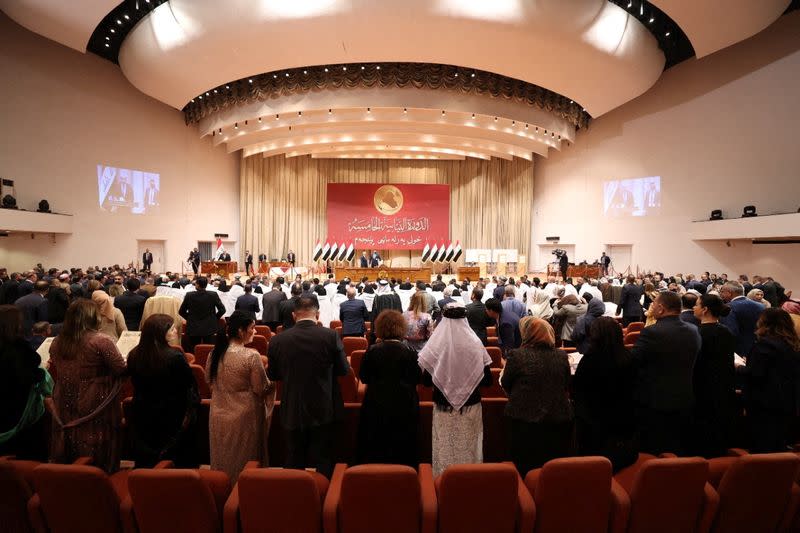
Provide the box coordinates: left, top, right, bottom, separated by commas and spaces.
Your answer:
0, 453, 800, 533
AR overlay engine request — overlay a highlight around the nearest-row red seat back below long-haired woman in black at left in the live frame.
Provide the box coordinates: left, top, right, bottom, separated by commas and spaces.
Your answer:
128, 469, 230, 533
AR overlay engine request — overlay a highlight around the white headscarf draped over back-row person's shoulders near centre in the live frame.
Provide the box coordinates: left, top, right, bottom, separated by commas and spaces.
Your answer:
419, 304, 492, 409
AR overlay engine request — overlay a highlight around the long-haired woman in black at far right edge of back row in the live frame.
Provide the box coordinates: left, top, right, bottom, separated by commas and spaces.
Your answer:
743, 308, 800, 453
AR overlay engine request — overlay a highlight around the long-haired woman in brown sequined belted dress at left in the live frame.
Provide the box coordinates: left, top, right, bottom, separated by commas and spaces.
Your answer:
50, 298, 126, 472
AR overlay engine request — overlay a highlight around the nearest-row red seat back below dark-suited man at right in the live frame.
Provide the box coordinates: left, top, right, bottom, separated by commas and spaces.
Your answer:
628, 457, 708, 533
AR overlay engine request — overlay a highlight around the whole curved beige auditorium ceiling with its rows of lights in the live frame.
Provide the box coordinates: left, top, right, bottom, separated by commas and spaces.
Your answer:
0, 0, 797, 159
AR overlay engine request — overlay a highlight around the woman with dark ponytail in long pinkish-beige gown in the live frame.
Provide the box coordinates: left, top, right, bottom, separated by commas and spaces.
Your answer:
206, 311, 275, 483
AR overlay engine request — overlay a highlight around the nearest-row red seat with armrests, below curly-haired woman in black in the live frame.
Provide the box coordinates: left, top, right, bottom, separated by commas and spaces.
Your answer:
322, 464, 436, 533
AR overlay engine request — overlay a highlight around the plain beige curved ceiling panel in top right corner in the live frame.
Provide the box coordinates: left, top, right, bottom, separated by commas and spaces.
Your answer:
650, 0, 791, 58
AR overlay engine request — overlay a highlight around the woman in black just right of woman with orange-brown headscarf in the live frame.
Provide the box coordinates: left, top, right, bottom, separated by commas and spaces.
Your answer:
572, 316, 638, 471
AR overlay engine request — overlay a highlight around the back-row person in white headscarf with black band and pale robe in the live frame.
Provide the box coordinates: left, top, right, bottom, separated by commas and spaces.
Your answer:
419, 304, 492, 476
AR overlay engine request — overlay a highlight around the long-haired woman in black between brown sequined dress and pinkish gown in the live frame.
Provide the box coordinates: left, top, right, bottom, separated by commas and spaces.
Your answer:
128, 314, 200, 468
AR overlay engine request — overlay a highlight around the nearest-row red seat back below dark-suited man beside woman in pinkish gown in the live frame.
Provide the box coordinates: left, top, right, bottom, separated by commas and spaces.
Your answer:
237, 468, 327, 533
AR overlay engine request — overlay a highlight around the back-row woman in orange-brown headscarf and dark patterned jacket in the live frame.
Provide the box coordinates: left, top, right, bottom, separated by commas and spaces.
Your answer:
500, 317, 572, 477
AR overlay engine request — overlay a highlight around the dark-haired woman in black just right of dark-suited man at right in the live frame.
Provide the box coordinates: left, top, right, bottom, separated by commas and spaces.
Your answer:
693, 294, 736, 458
